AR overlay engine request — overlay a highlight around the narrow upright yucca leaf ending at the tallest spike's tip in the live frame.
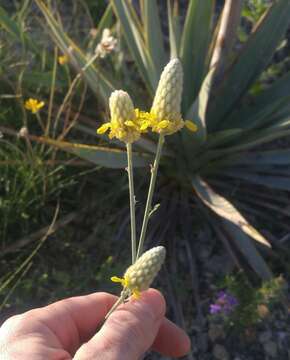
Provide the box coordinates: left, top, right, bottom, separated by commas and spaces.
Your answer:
142, 0, 168, 74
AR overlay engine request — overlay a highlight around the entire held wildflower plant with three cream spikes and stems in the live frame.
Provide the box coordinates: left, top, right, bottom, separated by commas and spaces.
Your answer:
97, 59, 197, 316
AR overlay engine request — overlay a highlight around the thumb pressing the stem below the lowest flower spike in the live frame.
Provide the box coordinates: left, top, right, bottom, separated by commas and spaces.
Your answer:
74, 289, 165, 360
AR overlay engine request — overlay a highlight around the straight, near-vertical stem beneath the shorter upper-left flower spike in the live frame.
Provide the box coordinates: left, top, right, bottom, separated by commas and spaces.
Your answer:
127, 144, 137, 264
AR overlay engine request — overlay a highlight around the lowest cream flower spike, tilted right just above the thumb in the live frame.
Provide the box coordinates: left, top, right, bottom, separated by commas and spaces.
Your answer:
111, 246, 166, 299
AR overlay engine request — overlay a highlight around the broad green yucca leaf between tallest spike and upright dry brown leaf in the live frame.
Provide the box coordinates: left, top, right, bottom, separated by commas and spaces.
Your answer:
180, 0, 214, 110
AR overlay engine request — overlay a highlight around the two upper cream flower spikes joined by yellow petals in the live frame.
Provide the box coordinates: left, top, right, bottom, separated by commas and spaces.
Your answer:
97, 59, 197, 143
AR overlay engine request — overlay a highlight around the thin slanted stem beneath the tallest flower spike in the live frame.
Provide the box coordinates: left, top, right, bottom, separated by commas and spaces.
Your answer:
137, 134, 164, 259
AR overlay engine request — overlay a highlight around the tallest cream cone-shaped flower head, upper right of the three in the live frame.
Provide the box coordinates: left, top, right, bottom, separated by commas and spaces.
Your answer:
151, 59, 184, 135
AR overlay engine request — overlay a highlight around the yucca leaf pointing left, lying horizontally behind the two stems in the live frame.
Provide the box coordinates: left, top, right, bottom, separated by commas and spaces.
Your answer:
33, 136, 152, 169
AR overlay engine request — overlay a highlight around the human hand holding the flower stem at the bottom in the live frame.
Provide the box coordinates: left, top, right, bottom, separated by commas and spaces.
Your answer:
0, 289, 190, 360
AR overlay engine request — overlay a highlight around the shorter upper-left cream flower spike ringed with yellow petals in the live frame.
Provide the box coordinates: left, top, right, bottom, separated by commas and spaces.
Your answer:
97, 90, 141, 144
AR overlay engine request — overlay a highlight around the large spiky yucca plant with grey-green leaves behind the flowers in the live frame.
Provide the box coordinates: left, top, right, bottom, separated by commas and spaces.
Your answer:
28, 0, 290, 279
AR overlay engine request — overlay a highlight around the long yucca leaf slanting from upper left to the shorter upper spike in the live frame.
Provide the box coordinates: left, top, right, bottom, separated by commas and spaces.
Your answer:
35, 0, 117, 100
